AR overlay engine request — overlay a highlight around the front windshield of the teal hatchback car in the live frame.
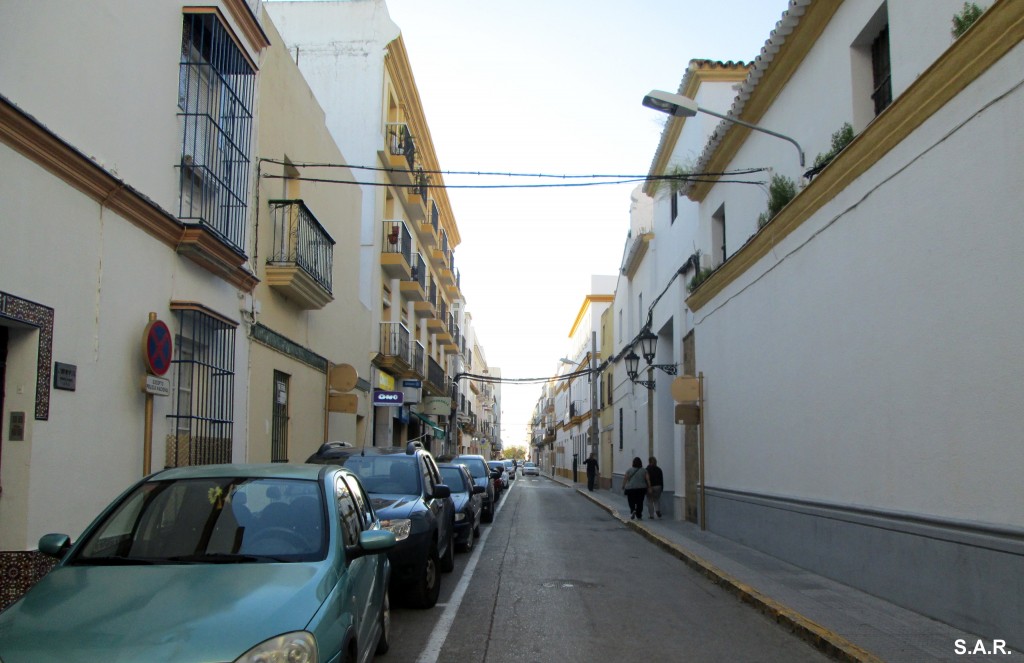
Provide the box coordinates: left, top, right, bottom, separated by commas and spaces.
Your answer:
69, 476, 327, 565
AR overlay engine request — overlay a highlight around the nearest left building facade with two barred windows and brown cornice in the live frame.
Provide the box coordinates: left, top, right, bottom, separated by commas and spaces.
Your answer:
0, 0, 268, 602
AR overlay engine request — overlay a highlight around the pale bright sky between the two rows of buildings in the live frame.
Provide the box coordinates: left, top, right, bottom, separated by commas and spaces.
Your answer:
386, 0, 787, 447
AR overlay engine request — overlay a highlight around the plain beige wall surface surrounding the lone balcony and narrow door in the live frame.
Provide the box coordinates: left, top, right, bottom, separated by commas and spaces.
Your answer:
247, 7, 372, 462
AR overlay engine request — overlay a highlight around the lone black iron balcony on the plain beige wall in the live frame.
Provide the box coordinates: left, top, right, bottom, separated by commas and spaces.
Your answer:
266, 200, 335, 308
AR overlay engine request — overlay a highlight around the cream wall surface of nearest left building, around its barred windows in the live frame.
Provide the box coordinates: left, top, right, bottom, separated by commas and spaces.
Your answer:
0, 0, 263, 550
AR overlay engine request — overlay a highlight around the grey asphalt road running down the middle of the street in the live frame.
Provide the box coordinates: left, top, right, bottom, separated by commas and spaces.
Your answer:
379, 476, 830, 663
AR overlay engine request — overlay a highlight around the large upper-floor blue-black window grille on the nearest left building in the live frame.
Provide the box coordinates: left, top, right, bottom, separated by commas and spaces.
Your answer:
178, 13, 256, 257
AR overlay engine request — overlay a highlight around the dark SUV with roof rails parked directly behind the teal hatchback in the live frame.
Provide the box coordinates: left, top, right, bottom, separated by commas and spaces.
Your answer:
306, 442, 455, 608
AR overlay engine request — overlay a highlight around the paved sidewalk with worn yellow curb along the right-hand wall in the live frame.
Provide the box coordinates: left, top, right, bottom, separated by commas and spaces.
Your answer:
543, 474, 1007, 663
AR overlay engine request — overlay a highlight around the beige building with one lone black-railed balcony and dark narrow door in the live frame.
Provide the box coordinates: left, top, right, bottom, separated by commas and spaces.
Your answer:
243, 9, 373, 462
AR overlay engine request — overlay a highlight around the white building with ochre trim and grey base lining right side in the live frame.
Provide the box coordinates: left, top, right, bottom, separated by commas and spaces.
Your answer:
638, 0, 1024, 637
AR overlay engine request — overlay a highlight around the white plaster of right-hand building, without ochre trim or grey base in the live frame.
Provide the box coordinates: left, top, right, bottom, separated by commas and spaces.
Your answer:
695, 7, 1024, 527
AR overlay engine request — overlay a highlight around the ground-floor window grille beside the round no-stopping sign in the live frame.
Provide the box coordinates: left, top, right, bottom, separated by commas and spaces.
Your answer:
167, 307, 234, 467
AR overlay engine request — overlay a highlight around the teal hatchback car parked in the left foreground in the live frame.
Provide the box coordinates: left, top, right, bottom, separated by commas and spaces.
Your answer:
0, 464, 395, 663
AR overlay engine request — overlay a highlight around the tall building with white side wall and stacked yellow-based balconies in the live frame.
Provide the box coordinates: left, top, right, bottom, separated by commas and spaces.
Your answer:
266, 0, 483, 453
